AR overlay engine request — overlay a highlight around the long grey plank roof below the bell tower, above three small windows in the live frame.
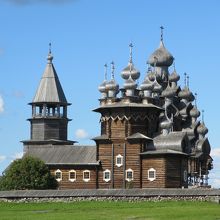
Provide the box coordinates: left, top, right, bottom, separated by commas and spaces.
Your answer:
24, 145, 99, 165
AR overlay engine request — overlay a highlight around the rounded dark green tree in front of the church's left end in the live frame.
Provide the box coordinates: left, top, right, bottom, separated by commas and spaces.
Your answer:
0, 156, 58, 190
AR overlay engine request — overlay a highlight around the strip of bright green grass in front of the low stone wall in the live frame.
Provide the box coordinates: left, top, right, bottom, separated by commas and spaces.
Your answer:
0, 201, 220, 220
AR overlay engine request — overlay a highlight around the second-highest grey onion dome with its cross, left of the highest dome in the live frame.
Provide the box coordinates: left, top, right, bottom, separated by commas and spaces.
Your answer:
121, 43, 140, 80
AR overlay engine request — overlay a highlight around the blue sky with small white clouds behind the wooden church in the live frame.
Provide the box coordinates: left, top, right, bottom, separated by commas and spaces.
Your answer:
0, 0, 220, 187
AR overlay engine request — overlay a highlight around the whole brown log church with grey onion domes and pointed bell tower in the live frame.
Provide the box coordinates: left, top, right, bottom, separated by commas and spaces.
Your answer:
23, 29, 212, 189
